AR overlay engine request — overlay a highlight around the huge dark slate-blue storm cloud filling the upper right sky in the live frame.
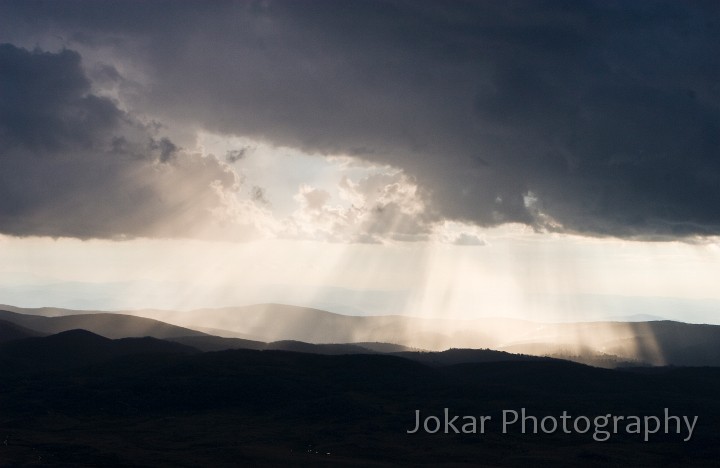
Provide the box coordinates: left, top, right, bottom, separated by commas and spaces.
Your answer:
0, 0, 720, 238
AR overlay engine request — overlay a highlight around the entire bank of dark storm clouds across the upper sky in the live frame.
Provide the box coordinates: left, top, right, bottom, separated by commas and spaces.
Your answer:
0, 0, 720, 239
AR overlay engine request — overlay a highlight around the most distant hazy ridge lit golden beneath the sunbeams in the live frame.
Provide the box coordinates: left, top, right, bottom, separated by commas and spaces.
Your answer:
129, 304, 720, 367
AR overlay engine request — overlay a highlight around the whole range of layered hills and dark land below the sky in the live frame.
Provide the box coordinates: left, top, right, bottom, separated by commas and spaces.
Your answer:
0, 305, 720, 467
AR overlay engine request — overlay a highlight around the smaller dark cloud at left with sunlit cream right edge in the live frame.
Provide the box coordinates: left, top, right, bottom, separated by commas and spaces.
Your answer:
0, 44, 242, 238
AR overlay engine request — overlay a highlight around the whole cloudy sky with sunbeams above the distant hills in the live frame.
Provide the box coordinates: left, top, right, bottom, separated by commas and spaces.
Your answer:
0, 0, 720, 323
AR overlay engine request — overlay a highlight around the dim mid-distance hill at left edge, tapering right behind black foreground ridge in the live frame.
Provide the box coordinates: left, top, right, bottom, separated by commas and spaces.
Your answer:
0, 310, 205, 339
